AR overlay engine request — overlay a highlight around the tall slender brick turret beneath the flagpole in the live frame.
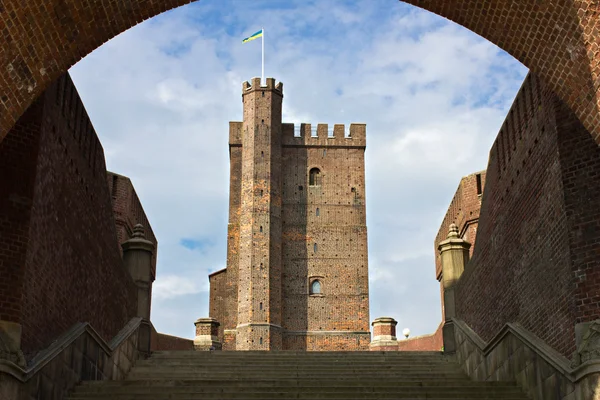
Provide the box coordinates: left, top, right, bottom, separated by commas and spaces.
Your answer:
236, 78, 283, 350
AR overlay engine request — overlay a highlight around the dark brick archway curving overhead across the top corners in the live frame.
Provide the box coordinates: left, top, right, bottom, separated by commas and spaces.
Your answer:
0, 0, 600, 143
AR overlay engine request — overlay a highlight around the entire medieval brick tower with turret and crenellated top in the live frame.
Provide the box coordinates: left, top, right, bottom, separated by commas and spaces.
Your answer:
209, 78, 370, 351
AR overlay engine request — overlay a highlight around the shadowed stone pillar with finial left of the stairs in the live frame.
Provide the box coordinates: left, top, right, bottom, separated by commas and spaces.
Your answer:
121, 224, 154, 320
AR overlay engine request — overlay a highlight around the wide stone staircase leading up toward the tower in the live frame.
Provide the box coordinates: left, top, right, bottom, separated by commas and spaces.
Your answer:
69, 351, 528, 400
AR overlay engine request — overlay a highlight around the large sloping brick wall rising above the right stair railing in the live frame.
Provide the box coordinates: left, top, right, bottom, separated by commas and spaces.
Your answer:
457, 74, 600, 357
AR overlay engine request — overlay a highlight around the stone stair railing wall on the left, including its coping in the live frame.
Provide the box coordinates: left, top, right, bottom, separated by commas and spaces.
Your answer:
0, 317, 152, 400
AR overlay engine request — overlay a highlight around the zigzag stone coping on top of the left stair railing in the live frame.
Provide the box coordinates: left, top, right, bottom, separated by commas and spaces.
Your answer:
0, 317, 145, 383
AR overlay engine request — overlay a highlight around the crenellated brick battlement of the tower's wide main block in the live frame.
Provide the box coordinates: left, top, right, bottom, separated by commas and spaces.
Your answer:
229, 121, 367, 148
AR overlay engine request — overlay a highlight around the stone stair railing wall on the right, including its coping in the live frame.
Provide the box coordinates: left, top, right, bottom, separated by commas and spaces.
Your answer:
452, 318, 600, 400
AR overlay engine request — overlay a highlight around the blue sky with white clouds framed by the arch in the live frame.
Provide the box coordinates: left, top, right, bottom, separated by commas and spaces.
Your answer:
71, 0, 527, 338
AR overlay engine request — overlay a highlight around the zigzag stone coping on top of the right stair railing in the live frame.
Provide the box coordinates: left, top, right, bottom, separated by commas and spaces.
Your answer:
451, 318, 600, 383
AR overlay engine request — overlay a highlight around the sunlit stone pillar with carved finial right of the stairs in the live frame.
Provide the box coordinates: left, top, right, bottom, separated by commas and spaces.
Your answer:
438, 224, 471, 353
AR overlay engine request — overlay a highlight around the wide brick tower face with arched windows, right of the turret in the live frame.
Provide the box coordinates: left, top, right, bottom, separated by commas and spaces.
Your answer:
282, 124, 370, 350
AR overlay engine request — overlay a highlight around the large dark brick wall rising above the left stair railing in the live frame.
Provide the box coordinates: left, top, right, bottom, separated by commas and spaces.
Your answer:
0, 72, 137, 357
